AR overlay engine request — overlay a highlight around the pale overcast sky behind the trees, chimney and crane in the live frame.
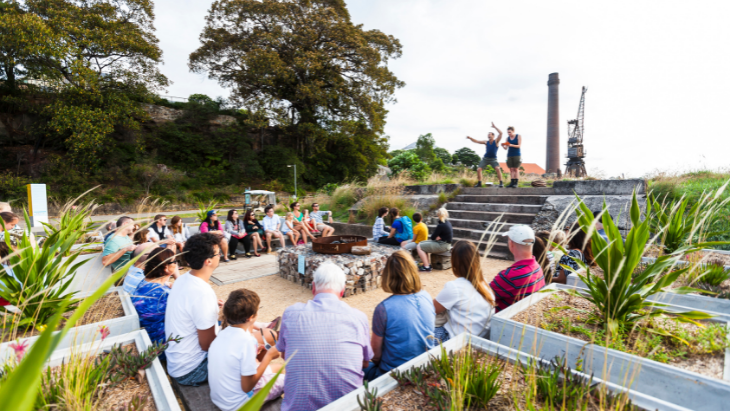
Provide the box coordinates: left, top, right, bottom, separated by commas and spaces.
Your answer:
155, 0, 730, 178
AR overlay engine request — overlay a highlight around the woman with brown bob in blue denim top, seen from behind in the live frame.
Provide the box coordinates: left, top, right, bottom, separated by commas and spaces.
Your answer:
365, 250, 436, 381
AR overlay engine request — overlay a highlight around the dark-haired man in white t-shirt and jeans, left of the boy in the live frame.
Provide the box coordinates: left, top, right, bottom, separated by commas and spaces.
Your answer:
165, 233, 223, 386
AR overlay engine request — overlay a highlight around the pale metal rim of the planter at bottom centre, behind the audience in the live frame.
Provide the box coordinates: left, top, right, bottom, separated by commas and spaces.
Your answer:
320, 333, 687, 411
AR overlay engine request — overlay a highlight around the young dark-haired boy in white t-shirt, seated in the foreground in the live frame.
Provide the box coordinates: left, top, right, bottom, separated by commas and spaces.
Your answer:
208, 289, 286, 411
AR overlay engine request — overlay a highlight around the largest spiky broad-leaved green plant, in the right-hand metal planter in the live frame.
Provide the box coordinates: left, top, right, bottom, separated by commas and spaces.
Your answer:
564, 192, 711, 335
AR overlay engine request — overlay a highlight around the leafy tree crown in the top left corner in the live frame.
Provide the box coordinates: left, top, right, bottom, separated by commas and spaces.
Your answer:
0, 0, 168, 171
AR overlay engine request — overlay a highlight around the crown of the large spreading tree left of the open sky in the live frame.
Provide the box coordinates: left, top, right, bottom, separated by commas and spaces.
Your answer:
189, 0, 404, 185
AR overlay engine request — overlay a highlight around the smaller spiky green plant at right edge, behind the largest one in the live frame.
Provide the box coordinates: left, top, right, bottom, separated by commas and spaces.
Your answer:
647, 180, 730, 254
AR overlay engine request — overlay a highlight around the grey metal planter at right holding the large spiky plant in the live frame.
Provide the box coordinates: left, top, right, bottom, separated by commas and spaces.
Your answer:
490, 284, 730, 411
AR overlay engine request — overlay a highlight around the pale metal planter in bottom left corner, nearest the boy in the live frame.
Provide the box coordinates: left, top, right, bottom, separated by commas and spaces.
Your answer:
47, 330, 181, 411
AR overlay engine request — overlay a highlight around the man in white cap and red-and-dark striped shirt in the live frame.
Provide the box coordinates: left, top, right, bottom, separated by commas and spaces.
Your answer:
486, 225, 545, 312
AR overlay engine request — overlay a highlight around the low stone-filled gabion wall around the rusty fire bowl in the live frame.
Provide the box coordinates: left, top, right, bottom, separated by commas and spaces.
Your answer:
278, 243, 398, 297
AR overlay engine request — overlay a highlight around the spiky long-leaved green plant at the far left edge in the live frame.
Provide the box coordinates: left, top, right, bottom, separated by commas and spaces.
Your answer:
0, 213, 87, 328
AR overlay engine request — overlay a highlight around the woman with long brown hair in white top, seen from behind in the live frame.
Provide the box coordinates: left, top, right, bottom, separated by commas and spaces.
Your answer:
433, 241, 494, 342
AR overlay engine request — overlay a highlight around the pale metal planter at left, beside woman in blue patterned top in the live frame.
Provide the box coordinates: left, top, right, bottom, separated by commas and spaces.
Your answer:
0, 287, 140, 361
